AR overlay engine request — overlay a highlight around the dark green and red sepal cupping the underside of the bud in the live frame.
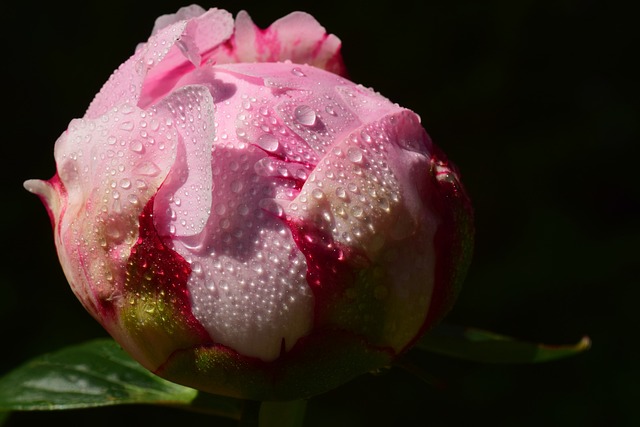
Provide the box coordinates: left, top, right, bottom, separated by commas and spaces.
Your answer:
156, 330, 394, 401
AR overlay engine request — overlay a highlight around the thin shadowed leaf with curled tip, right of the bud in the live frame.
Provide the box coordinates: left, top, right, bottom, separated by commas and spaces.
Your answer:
415, 325, 591, 363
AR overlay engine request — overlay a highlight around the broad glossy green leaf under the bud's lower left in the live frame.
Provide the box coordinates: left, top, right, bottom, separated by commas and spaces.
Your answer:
0, 339, 235, 412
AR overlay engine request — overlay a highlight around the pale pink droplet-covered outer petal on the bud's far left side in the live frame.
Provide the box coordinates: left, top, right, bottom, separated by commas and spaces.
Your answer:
56, 100, 178, 298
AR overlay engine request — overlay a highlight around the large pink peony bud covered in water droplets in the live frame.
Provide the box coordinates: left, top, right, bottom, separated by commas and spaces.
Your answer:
25, 5, 473, 400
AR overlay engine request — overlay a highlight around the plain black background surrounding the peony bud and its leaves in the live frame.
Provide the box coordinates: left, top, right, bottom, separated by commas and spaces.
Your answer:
0, 0, 640, 426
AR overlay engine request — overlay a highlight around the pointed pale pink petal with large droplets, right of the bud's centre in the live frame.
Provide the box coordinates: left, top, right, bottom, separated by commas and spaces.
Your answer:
289, 116, 400, 255
